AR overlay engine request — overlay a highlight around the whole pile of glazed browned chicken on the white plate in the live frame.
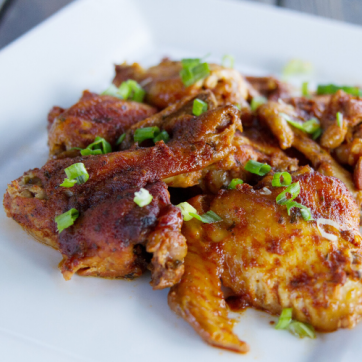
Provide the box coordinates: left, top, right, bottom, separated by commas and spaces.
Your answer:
4, 59, 362, 353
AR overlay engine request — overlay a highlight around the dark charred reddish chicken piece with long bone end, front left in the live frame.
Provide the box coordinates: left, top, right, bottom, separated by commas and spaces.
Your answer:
4, 94, 240, 289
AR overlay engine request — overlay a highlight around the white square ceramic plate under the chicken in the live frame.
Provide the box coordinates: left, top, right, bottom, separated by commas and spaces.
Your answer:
0, 0, 362, 362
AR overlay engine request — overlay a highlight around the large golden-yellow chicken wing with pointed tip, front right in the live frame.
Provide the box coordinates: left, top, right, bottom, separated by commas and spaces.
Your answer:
169, 166, 362, 352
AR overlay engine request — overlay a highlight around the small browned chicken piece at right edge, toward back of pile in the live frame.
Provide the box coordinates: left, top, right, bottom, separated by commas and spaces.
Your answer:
320, 90, 362, 149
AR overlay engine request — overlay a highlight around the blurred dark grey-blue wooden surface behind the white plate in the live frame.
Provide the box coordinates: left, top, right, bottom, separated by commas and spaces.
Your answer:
0, 0, 362, 49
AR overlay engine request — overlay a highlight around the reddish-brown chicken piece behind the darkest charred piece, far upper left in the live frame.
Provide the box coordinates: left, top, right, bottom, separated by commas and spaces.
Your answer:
48, 91, 156, 158
